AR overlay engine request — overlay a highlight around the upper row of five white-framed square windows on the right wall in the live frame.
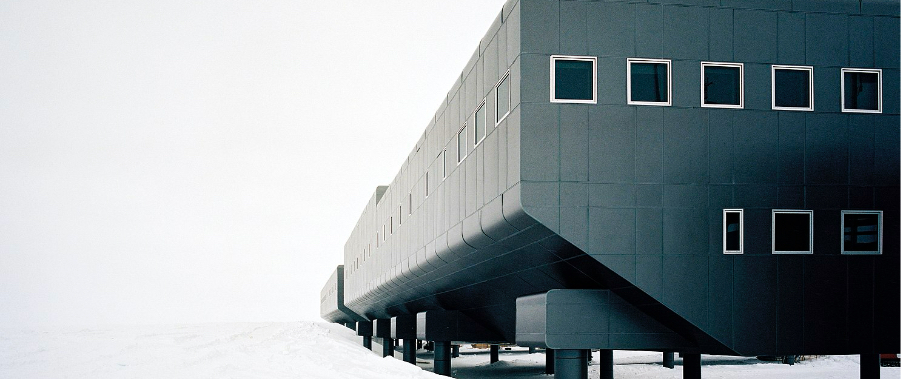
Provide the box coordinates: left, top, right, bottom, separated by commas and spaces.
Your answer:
550, 55, 882, 113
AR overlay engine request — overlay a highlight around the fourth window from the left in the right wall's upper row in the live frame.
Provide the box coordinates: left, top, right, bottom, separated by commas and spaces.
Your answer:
772, 65, 813, 111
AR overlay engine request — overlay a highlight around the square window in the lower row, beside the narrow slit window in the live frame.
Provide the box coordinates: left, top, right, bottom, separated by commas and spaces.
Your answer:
773, 210, 813, 254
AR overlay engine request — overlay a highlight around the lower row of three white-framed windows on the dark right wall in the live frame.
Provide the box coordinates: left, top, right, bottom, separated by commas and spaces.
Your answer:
723, 209, 882, 254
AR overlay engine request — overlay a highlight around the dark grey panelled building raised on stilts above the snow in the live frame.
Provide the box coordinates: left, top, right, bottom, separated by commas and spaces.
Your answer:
323, 0, 901, 375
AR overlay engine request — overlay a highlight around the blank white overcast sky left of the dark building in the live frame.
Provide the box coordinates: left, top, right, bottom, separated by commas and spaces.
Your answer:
0, 0, 504, 327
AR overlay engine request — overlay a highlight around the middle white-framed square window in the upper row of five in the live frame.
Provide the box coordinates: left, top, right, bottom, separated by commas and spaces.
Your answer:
701, 62, 744, 108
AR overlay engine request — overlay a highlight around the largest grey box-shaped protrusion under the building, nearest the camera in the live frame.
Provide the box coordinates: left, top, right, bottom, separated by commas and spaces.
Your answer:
516, 290, 694, 350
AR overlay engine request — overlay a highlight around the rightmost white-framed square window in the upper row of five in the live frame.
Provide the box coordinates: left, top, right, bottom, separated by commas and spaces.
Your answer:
842, 68, 882, 113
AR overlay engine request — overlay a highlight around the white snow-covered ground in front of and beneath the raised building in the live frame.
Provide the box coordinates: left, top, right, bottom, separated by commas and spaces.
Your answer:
0, 322, 901, 379
